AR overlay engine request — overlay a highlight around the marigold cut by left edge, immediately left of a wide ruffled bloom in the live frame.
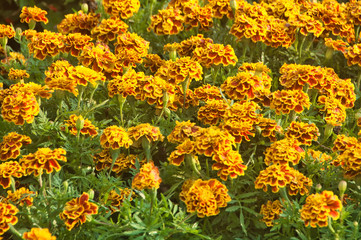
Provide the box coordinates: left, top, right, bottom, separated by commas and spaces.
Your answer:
0, 161, 25, 188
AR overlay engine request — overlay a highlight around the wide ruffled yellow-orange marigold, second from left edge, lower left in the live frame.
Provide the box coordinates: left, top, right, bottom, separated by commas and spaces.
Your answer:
19, 148, 67, 177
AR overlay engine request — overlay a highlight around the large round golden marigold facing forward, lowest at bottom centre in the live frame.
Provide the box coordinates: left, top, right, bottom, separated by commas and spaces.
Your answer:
180, 179, 231, 218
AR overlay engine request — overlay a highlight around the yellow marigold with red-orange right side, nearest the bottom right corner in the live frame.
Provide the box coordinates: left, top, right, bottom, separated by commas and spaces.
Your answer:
300, 191, 342, 228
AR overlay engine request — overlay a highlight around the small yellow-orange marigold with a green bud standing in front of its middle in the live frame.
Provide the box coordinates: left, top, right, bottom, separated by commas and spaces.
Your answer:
61, 114, 98, 137
